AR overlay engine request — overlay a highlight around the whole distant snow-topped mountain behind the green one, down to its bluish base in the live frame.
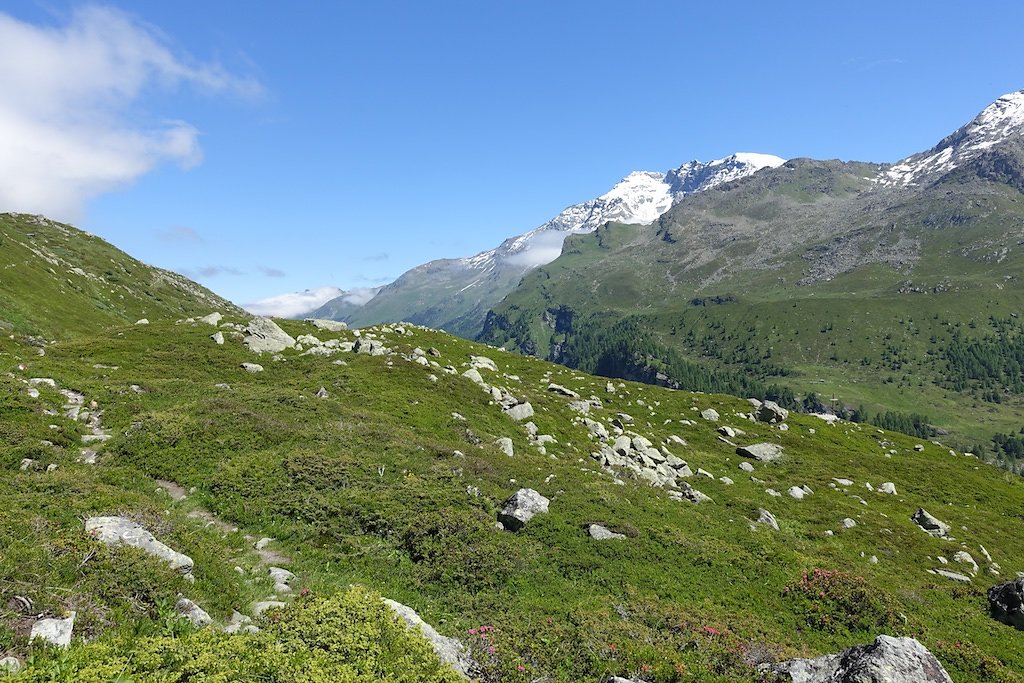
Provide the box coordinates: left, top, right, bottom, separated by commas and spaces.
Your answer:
313, 153, 783, 337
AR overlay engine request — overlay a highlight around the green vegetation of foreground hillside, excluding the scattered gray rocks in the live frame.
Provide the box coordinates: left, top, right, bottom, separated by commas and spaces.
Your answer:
0, 313, 1024, 681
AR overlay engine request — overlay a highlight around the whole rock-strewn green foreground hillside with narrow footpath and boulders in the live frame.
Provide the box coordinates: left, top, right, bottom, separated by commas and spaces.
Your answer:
0, 219, 1024, 683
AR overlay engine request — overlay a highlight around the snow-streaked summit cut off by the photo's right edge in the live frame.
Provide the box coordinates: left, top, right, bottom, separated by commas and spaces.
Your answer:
878, 90, 1024, 186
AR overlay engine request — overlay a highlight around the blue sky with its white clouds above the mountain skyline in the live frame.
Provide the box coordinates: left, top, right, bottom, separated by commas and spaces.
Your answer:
0, 0, 1024, 313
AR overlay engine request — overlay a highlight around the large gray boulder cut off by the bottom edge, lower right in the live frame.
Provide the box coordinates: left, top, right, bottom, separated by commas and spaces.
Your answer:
767, 636, 952, 683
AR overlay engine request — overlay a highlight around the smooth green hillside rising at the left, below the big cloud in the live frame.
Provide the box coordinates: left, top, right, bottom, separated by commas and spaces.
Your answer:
0, 213, 237, 336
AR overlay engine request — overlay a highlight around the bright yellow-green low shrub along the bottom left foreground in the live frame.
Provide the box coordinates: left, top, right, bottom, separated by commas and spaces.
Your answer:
12, 588, 461, 683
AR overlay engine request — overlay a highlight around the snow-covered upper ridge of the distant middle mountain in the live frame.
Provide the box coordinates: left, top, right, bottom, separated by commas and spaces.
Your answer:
461, 152, 785, 270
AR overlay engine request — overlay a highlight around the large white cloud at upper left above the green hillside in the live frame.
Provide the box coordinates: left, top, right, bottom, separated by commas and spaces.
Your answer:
0, 5, 261, 219
